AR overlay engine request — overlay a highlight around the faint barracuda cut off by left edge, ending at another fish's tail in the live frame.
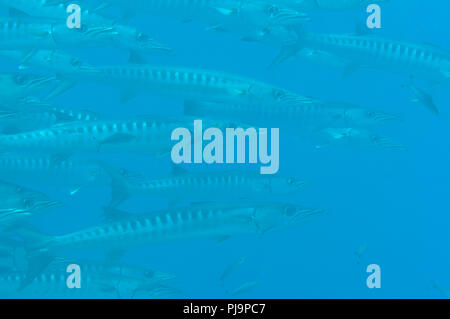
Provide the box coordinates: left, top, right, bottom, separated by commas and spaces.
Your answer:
0, 154, 110, 195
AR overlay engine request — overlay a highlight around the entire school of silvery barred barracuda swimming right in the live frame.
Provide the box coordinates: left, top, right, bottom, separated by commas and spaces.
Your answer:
0, 0, 444, 298
